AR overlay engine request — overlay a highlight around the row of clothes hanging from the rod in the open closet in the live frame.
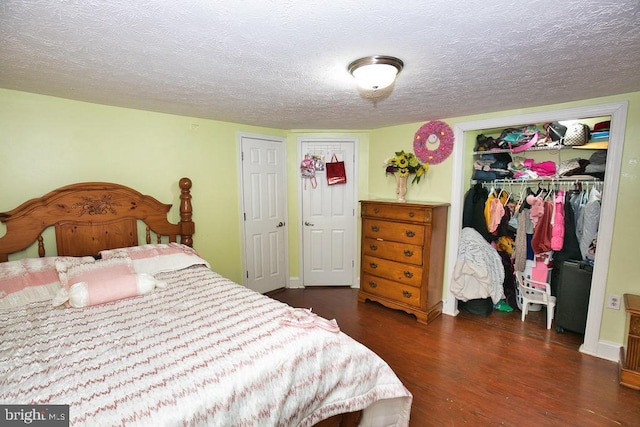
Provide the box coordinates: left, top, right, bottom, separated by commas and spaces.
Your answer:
463, 182, 601, 308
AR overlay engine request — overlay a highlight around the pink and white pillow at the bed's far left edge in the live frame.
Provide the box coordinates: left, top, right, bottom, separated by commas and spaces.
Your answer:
0, 257, 93, 309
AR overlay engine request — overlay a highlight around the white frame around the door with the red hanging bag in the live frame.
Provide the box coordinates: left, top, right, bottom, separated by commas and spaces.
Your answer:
296, 135, 360, 288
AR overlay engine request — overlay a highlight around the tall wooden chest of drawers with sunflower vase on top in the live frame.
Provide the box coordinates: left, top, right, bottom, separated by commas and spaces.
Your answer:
358, 200, 449, 324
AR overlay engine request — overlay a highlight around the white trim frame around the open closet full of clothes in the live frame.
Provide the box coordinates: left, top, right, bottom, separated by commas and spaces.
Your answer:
443, 101, 628, 361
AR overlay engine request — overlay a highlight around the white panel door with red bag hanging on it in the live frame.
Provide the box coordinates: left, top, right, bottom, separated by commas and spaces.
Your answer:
298, 137, 358, 286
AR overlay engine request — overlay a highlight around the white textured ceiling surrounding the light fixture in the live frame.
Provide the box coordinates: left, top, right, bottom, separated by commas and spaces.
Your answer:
0, 0, 640, 129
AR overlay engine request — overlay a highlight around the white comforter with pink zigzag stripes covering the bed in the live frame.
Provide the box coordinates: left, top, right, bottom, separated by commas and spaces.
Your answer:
0, 266, 411, 427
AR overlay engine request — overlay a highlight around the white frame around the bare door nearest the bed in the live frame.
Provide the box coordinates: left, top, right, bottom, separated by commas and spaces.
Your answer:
237, 132, 289, 288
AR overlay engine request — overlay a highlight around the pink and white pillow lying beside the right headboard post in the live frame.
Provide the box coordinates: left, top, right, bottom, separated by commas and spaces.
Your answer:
100, 243, 211, 274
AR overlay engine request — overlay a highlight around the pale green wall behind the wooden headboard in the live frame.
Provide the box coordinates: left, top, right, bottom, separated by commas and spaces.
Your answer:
0, 89, 285, 282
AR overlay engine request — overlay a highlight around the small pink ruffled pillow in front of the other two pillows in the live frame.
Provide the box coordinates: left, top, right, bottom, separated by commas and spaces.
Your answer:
53, 253, 164, 308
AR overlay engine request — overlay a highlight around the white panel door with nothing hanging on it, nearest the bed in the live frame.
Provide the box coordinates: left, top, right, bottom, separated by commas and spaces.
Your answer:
240, 135, 287, 293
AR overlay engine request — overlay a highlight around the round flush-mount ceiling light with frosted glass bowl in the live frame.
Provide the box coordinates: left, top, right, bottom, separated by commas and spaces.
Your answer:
347, 55, 404, 90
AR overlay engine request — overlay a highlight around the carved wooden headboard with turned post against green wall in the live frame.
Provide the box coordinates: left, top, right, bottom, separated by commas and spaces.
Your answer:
0, 178, 195, 262
